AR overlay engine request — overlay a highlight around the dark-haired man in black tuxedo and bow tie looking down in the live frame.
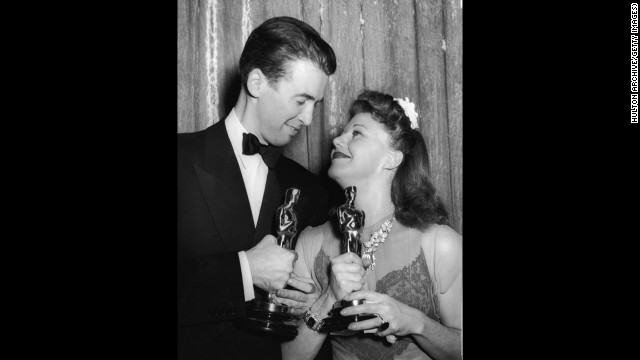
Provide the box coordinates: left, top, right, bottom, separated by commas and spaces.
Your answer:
178, 17, 336, 360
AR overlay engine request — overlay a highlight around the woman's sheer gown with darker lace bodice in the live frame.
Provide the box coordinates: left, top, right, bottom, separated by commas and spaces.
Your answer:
296, 213, 446, 360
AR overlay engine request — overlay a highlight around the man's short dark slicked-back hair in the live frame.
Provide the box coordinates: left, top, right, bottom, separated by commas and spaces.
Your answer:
239, 16, 336, 95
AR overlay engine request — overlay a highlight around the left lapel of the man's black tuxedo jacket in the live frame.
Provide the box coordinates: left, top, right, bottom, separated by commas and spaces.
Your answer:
194, 121, 255, 251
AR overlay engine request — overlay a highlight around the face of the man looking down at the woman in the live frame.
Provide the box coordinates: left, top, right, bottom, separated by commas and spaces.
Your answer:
256, 59, 329, 146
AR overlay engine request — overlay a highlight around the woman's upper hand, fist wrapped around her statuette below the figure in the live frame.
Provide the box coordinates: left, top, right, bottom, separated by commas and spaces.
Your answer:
329, 252, 364, 301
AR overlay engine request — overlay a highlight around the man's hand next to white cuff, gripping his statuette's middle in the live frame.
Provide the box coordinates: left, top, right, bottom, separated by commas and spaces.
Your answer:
246, 235, 298, 292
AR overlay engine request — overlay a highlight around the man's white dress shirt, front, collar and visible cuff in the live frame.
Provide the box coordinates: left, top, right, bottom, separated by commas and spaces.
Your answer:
224, 109, 269, 301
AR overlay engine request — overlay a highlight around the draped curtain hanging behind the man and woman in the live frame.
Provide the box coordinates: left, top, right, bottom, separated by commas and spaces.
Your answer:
177, 0, 462, 234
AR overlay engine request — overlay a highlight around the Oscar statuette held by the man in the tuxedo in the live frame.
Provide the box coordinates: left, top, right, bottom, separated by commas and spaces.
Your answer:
241, 188, 300, 338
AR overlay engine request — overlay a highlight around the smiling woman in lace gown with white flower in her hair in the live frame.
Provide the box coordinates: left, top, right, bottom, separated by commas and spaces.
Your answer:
278, 91, 462, 359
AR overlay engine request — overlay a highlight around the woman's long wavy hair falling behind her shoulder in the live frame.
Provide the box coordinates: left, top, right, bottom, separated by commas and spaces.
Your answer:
349, 90, 449, 230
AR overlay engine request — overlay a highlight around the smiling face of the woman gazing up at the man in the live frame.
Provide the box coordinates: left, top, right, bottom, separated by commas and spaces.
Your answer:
328, 113, 391, 187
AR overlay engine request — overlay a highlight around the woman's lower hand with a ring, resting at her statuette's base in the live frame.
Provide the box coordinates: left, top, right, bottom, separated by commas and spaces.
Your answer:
340, 290, 425, 343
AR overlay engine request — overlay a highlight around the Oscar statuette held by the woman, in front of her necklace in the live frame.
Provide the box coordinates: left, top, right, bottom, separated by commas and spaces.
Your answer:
319, 186, 375, 336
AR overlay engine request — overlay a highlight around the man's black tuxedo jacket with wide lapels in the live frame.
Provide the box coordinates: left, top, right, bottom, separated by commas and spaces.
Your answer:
178, 121, 328, 360
